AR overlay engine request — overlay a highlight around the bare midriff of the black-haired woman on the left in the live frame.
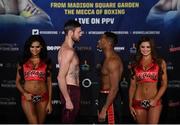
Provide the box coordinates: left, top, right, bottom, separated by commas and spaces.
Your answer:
24, 81, 47, 94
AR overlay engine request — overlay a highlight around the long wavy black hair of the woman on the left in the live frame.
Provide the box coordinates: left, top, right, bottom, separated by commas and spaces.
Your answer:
19, 35, 51, 82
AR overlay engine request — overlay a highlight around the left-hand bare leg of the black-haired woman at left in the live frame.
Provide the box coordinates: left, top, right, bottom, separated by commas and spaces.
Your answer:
21, 99, 38, 124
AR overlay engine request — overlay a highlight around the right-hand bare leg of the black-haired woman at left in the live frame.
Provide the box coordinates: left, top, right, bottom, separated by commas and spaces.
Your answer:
36, 100, 48, 124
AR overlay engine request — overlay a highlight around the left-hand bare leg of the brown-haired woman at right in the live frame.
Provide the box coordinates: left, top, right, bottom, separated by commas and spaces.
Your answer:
135, 109, 147, 124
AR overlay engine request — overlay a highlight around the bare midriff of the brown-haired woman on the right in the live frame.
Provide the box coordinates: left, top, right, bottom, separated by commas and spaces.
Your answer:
134, 83, 158, 100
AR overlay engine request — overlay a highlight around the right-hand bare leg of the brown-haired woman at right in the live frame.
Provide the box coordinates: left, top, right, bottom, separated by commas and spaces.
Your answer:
148, 105, 162, 124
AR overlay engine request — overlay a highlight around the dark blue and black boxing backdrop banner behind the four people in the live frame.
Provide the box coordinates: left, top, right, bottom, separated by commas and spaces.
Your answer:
0, 0, 180, 124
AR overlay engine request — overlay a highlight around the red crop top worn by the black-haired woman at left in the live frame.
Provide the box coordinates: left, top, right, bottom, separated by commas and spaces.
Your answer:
23, 61, 47, 81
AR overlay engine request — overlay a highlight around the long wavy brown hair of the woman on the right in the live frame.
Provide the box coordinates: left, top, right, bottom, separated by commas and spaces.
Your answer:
131, 36, 163, 80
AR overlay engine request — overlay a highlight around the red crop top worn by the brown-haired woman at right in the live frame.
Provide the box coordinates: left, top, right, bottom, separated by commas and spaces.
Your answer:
135, 61, 159, 83
